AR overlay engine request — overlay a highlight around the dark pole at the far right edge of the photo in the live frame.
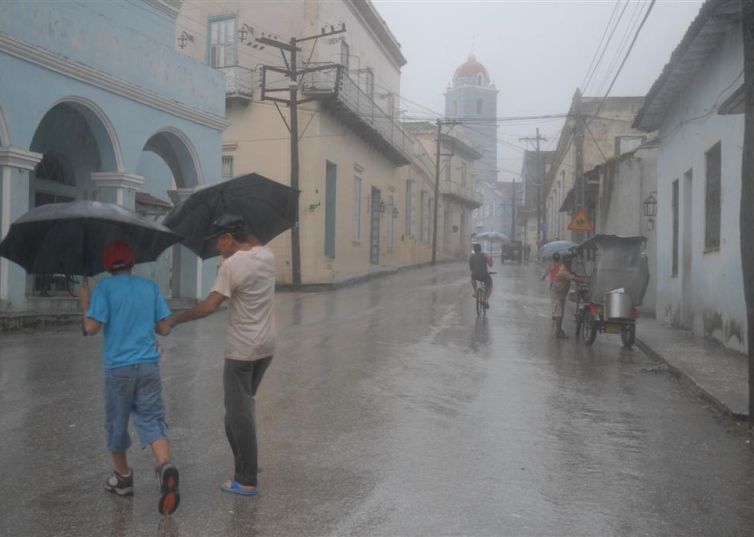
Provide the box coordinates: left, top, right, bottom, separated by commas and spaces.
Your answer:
739, 0, 754, 418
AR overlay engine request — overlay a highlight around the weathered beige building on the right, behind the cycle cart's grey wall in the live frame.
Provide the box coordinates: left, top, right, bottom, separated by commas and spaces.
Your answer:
543, 90, 646, 241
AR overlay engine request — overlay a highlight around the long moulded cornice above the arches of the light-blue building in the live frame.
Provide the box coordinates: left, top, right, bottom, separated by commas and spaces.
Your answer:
0, 32, 229, 131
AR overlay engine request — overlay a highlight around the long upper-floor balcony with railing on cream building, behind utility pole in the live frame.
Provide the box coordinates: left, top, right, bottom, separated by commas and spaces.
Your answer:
303, 65, 412, 166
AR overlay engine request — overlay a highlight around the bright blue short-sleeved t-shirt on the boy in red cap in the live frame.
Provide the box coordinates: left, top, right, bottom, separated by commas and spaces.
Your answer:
87, 274, 170, 369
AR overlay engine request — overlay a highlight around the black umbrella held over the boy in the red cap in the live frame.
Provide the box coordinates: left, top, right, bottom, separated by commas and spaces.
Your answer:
0, 201, 181, 276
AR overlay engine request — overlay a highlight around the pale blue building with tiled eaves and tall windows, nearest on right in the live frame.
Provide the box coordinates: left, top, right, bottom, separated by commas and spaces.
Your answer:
634, 0, 747, 351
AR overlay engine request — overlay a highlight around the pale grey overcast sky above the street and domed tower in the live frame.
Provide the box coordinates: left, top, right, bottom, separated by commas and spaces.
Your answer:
373, 0, 702, 181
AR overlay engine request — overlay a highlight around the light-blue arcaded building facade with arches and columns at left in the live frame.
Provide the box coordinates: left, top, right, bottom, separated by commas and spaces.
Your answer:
0, 0, 227, 311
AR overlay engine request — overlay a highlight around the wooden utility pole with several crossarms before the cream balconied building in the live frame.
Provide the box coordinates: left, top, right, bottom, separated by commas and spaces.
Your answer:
255, 24, 346, 285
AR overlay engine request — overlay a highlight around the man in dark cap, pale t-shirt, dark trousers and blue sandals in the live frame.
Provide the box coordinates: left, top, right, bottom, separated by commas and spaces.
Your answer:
170, 214, 275, 496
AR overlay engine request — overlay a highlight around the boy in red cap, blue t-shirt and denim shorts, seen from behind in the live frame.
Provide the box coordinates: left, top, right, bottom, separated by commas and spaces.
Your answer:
79, 242, 180, 514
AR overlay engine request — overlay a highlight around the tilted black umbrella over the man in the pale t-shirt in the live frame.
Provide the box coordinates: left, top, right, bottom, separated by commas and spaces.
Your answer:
164, 173, 299, 259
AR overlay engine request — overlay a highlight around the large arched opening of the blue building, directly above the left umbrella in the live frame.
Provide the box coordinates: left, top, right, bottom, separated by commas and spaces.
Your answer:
27, 97, 122, 296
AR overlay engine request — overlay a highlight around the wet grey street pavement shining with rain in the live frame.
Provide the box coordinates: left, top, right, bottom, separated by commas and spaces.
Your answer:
0, 264, 754, 537
